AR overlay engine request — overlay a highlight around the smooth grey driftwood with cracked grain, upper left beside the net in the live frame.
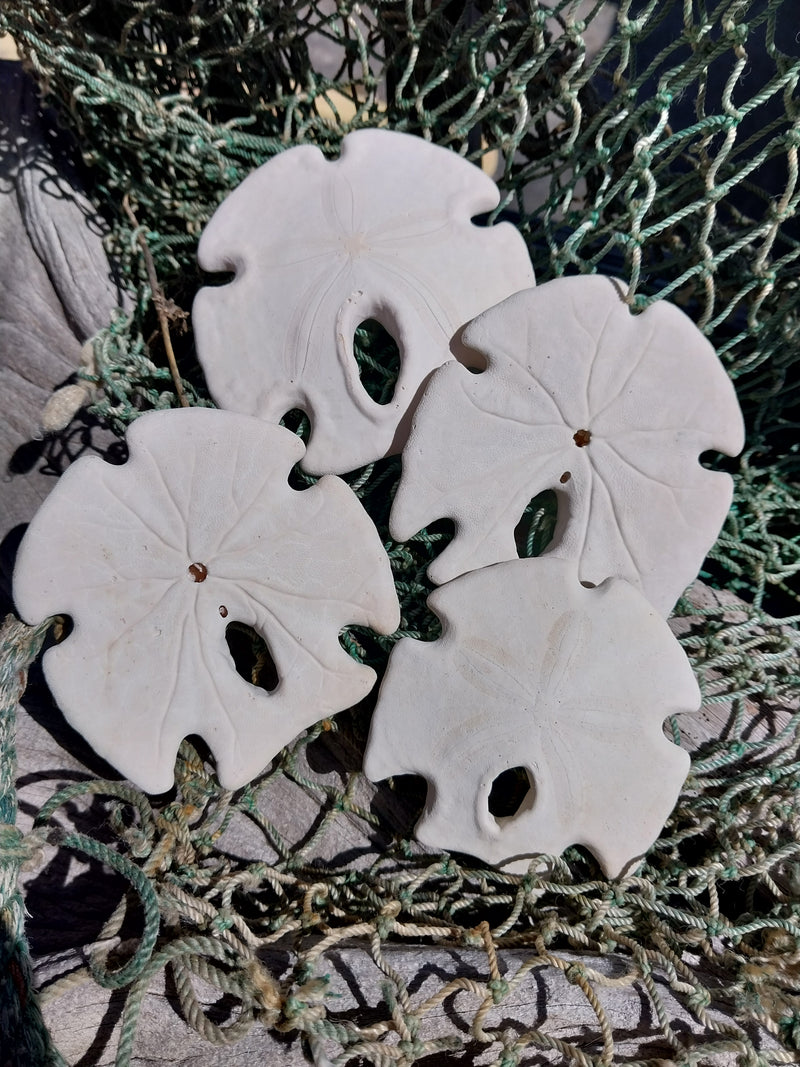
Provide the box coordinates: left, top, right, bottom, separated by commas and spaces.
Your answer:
0, 60, 119, 567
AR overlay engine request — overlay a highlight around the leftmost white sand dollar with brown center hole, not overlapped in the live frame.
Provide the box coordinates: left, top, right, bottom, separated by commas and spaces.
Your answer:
14, 409, 407, 793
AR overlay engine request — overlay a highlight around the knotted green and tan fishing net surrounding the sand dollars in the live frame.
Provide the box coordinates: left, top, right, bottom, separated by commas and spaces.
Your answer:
0, 0, 800, 1067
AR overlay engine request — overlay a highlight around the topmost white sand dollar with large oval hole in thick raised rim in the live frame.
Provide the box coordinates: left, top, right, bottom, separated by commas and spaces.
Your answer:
192, 129, 533, 474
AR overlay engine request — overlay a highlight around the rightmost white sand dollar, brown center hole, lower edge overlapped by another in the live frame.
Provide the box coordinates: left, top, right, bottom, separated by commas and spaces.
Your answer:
391, 276, 743, 615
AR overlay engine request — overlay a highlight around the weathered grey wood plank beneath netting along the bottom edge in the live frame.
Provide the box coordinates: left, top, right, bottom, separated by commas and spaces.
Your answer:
26, 943, 780, 1067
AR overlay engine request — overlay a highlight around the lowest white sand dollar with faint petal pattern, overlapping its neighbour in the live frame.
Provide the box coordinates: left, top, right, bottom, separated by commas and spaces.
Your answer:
364, 559, 700, 877
